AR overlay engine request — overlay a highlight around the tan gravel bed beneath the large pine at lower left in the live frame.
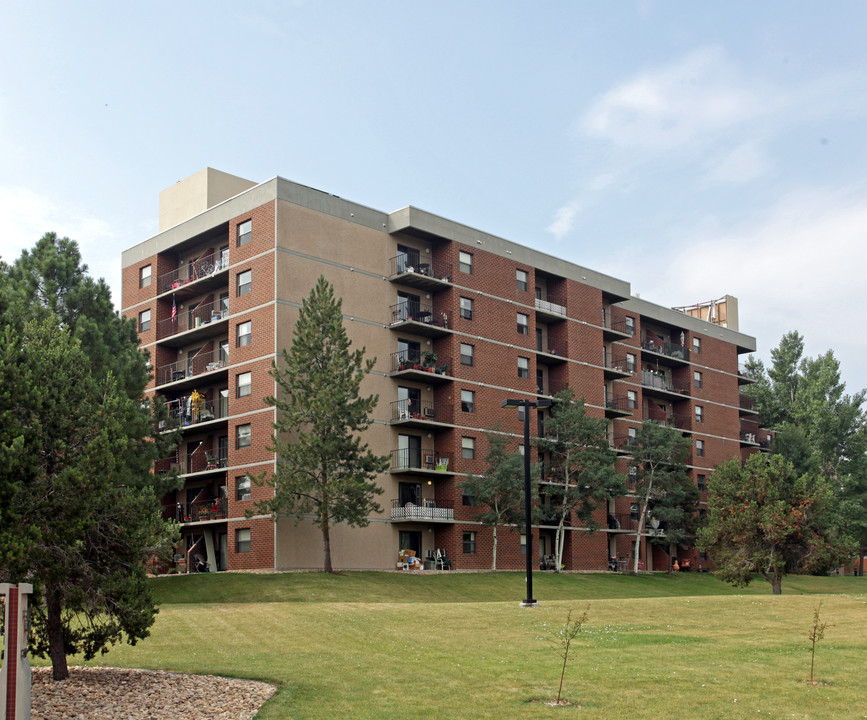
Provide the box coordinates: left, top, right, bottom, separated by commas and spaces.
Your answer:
30, 667, 276, 720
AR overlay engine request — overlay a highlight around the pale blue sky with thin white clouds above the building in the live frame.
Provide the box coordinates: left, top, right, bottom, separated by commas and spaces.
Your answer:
0, 0, 867, 392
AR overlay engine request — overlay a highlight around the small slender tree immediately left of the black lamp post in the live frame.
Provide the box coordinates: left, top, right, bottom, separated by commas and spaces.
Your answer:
461, 432, 525, 570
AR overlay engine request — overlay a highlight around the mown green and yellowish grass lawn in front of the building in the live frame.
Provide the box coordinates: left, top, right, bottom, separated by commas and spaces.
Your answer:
50, 573, 867, 720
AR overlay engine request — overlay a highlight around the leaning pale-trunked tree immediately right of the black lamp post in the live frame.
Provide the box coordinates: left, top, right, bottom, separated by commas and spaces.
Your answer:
536, 388, 626, 572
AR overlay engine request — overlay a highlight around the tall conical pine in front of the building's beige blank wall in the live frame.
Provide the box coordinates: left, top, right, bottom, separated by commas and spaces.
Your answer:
258, 276, 389, 573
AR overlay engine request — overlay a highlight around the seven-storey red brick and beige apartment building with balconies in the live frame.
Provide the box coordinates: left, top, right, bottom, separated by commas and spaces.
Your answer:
122, 168, 767, 570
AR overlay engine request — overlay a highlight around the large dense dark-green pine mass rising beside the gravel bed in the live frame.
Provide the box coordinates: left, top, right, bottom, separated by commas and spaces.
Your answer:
0, 233, 177, 679
